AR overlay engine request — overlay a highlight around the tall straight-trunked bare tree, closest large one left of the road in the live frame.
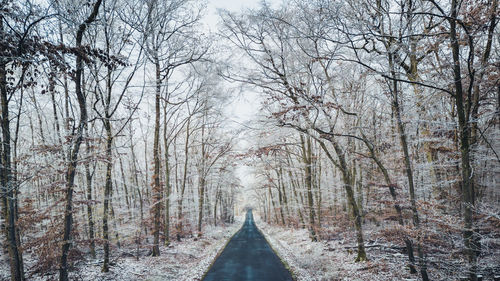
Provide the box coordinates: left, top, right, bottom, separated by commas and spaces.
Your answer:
132, 0, 206, 256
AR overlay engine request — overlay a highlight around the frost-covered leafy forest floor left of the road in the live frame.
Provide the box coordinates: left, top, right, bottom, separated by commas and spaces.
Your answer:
0, 215, 244, 281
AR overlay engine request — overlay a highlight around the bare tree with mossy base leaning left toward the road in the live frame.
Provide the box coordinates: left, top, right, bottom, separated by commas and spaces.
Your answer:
223, 6, 366, 261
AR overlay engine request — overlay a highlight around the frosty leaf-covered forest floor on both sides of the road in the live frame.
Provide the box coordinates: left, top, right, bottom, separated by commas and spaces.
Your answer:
0, 210, 500, 281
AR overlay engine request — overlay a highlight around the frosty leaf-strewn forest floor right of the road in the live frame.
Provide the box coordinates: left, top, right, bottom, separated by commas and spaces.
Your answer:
255, 214, 500, 281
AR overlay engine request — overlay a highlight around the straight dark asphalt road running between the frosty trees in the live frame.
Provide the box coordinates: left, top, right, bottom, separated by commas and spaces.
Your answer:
203, 210, 293, 281
